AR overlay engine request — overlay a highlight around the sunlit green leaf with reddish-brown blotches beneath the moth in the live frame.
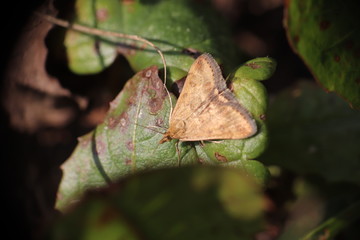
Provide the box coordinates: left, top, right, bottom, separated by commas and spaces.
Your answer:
56, 55, 269, 209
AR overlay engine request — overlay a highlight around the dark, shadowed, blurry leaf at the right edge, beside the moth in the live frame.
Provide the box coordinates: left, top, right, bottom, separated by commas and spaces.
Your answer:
262, 82, 360, 184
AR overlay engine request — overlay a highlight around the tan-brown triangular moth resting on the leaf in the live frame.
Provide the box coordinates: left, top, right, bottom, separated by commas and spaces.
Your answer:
160, 53, 257, 143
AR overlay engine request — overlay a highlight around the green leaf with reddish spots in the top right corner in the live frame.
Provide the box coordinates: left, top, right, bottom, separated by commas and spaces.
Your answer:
285, 0, 360, 108
